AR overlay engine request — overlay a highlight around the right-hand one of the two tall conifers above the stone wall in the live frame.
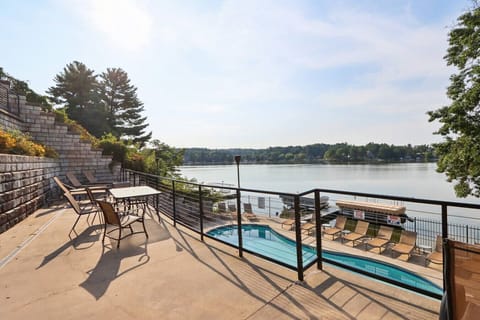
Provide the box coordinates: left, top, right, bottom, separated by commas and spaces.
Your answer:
99, 68, 152, 145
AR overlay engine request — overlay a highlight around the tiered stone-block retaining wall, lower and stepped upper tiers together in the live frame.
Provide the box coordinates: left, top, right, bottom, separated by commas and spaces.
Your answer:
0, 82, 119, 233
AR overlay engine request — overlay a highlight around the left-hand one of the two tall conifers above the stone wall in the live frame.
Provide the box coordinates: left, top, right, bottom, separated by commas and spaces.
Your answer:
47, 61, 109, 137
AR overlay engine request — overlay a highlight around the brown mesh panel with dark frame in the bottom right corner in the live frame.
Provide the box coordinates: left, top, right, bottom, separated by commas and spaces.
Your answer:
443, 239, 480, 319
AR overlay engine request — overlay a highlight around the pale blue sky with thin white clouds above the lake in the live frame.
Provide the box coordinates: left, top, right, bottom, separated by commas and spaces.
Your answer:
0, 0, 471, 148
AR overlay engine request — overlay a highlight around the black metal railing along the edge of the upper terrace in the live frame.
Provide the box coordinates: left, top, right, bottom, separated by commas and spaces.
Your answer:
121, 169, 480, 298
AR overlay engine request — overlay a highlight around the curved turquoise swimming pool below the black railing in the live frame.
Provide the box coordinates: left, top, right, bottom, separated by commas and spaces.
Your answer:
207, 224, 443, 295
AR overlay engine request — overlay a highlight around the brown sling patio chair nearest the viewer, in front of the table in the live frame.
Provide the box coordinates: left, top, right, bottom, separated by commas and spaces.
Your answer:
97, 201, 148, 249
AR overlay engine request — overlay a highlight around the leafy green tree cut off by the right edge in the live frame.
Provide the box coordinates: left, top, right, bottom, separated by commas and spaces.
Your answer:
428, 2, 480, 197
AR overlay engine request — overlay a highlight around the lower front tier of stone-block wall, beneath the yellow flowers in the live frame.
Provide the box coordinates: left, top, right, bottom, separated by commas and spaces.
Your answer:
0, 154, 60, 233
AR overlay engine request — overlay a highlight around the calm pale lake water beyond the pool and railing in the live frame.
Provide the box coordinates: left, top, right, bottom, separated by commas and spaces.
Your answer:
180, 163, 480, 221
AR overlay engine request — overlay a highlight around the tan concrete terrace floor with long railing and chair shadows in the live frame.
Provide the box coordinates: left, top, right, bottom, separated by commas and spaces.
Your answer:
0, 206, 439, 319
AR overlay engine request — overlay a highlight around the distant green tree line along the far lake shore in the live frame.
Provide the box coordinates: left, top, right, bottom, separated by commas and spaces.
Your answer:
183, 142, 435, 165
